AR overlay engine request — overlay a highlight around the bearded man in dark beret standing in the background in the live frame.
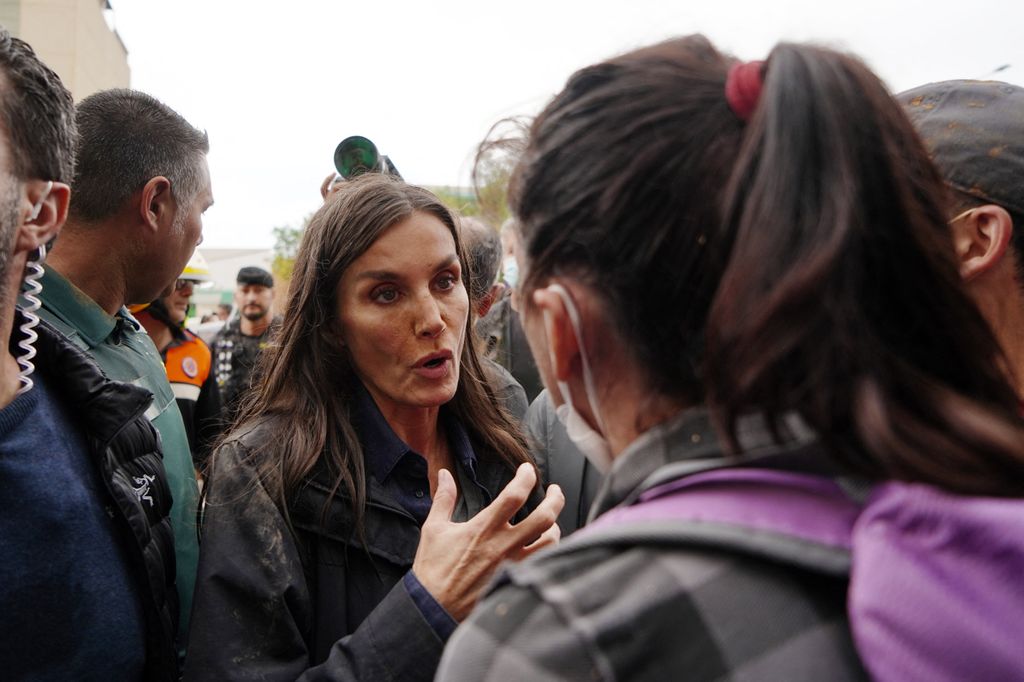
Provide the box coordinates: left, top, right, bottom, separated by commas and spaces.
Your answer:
213, 265, 280, 425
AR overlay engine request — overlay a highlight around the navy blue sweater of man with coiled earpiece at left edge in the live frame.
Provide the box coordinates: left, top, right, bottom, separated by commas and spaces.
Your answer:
0, 373, 145, 680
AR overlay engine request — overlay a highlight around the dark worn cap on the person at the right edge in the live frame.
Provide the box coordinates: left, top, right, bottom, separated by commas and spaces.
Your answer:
896, 81, 1024, 215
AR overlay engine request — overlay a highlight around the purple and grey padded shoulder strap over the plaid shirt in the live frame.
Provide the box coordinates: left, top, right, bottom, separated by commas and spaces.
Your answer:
573, 468, 860, 574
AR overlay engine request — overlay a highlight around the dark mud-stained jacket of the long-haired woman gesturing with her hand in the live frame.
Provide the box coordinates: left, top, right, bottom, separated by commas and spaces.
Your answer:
184, 417, 536, 682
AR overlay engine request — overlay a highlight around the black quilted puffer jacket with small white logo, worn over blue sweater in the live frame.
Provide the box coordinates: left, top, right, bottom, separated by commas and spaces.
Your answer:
30, 321, 178, 681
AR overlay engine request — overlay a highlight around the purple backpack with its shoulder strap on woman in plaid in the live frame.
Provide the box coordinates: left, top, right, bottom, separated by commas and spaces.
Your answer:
562, 468, 1024, 682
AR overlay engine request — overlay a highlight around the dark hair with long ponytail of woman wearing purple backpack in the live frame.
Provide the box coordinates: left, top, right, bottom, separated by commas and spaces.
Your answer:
511, 36, 1024, 495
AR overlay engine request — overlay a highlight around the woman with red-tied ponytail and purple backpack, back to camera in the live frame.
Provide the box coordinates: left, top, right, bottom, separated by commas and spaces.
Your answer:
437, 36, 1024, 682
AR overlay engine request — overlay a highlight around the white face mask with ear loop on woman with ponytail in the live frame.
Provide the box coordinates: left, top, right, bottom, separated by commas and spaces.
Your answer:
544, 284, 611, 473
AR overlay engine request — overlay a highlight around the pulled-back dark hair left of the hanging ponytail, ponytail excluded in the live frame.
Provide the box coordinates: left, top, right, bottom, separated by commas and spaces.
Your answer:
510, 37, 742, 402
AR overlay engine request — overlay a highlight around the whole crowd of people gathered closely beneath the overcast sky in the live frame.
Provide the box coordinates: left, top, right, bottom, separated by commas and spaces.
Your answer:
0, 22, 1024, 681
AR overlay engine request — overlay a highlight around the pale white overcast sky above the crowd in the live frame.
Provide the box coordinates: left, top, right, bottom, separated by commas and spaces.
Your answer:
112, 0, 1024, 247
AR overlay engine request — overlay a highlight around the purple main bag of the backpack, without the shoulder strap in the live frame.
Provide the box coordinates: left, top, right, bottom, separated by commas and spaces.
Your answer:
847, 482, 1024, 682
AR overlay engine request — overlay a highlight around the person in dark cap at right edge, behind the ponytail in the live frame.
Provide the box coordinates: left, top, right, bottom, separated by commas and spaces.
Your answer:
896, 81, 1024, 396
